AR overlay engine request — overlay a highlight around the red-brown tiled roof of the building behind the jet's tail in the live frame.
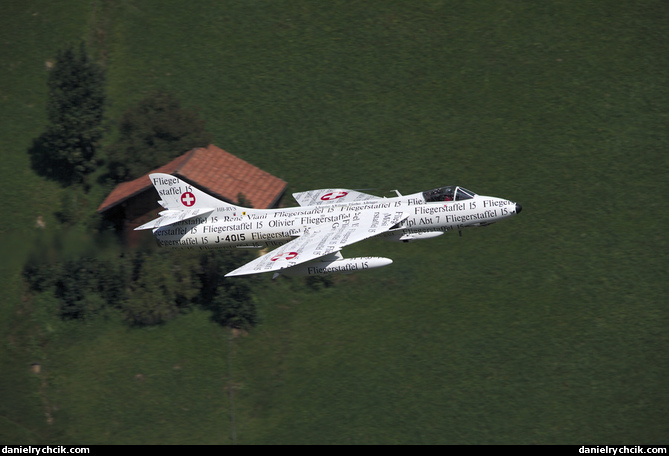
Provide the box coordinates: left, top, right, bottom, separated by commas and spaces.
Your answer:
98, 145, 286, 212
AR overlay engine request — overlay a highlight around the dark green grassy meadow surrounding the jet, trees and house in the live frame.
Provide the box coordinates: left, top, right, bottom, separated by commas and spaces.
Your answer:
0, 0, 669, 445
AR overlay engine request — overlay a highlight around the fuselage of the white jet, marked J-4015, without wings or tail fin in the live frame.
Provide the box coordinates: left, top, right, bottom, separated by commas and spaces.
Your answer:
154, 193, 521, 250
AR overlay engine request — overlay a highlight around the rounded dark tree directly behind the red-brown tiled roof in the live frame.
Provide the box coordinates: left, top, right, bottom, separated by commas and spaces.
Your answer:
107, 91, 212, 182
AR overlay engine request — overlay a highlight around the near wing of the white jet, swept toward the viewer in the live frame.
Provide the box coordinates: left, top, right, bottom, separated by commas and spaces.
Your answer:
225, 209, 409, 277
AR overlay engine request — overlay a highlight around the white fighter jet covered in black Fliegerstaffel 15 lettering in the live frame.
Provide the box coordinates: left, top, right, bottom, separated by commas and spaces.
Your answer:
135, 173, 522, 277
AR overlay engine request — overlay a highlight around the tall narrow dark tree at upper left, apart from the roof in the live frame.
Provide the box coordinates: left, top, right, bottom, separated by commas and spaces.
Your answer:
29, 42, 105, 185
